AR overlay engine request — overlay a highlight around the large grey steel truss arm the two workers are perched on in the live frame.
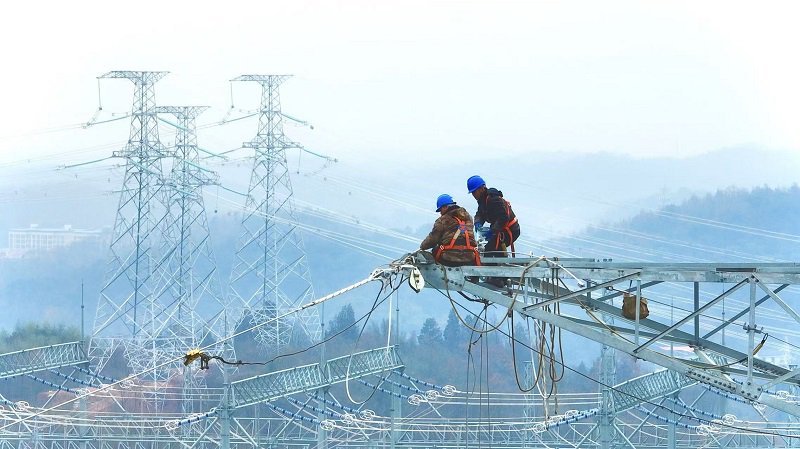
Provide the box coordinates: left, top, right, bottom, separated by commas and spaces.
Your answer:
404, 254, 800, 447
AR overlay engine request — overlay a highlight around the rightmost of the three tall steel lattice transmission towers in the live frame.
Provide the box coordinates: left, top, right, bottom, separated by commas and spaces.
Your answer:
230, 75, 321, 350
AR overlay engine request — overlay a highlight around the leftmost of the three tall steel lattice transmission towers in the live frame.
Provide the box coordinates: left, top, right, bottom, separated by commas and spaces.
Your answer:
89, 71, 178, 382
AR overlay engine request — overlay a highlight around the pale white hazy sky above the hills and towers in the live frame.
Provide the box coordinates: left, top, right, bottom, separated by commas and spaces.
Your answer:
0, 0, 800, 166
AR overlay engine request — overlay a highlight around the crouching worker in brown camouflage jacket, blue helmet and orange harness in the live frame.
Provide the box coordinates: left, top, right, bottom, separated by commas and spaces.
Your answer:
419, 193, 481, 266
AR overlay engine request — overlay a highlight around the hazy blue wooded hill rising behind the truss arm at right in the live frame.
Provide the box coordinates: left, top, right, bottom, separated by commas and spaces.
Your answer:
547, 185, 800, 262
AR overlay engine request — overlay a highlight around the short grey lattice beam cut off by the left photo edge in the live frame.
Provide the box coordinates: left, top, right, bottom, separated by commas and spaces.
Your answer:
0, 341, 89, 379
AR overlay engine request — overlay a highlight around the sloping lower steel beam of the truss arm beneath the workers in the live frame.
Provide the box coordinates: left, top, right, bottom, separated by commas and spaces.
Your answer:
417, 264, 800, 416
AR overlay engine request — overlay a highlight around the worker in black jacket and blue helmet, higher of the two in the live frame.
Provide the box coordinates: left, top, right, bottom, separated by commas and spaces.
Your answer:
467, 175, 520, 257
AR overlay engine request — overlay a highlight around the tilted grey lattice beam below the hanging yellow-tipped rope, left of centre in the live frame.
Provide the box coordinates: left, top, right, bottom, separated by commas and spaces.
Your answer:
231, 346, 403, 408
